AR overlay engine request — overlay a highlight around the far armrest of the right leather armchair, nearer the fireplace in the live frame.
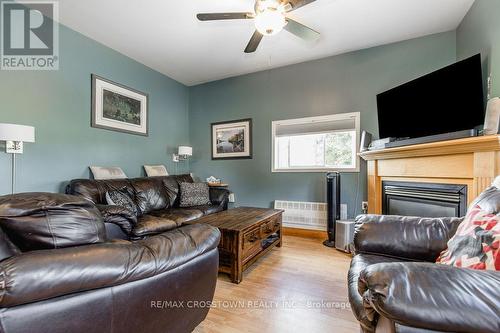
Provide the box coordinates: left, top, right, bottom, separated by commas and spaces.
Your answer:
354, 215, 463, 262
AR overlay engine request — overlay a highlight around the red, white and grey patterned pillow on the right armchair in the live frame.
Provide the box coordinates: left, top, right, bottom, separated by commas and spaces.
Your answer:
436, 205, 500, 271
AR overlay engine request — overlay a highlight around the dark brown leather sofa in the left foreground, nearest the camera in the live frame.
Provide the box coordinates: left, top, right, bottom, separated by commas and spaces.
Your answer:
0, 182, 220, 333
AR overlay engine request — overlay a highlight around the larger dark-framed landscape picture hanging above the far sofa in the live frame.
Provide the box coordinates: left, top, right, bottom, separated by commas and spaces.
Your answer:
92, 74, 148, 136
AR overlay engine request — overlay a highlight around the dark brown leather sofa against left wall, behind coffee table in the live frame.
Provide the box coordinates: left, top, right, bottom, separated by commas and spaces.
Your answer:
66, 174, 229, 239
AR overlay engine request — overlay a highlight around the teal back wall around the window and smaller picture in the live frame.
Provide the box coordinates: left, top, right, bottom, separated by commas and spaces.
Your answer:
189, 32, 456, 217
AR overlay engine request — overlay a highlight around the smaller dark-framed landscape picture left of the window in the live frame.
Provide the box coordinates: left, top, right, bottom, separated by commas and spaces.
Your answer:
212, 119, 252, 160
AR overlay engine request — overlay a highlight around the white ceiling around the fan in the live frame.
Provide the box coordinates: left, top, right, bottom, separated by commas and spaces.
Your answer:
59, 0, 474, 86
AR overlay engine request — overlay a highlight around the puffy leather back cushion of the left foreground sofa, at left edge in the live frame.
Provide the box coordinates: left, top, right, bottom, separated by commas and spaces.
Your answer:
0, 193, 106, 252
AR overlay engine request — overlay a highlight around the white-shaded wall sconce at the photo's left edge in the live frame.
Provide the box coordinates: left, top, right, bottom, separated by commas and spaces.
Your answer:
0, 123, 35, 194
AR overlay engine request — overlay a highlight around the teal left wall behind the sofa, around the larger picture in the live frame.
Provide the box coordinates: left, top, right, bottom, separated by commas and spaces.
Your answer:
0, 26, 189, 194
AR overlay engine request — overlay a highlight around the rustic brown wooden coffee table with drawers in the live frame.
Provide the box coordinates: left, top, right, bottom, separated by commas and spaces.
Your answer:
193, 207, 283, 283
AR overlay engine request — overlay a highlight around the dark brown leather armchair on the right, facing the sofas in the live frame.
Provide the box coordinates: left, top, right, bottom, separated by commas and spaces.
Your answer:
348, 187, 500, 333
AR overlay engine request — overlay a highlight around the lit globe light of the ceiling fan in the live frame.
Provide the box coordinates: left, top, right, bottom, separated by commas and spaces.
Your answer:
255, 1, 286, 36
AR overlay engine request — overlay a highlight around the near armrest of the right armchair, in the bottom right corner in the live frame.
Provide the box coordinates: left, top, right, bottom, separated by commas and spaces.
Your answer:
359, 263, 500, 333
